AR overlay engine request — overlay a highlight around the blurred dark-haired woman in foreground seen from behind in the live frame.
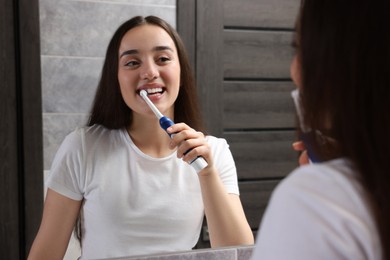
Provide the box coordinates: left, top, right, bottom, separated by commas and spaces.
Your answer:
252, 0, 390, 260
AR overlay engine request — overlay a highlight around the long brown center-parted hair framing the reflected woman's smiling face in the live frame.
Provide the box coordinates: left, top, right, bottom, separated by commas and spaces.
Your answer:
88, 16, 205, 132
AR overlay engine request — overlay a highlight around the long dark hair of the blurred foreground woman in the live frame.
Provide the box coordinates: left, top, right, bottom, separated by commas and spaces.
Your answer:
297, 0, 390, 259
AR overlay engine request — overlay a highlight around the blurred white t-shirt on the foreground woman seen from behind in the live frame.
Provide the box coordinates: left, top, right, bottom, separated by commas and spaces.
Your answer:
251, 159, 381, 260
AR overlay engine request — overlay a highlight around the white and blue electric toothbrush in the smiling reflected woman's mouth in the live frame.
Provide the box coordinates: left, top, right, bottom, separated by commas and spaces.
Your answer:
140, 90, 208, 172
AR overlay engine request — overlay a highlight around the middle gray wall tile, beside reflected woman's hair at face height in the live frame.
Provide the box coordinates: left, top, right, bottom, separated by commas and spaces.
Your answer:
41, 56, 103, 113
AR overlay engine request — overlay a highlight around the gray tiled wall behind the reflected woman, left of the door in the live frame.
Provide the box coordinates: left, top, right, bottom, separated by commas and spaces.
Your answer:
39, 0, 176, 259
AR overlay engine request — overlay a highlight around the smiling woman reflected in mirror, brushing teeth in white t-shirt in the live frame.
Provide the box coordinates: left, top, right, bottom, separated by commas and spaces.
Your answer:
29, 16, 253, 259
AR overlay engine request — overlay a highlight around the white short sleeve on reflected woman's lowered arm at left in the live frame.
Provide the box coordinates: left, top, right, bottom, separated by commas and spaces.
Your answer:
46, 129, 85, 200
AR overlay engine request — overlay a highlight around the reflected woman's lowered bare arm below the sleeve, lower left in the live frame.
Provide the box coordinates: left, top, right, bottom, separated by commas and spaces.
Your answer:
28, 188, 82, 260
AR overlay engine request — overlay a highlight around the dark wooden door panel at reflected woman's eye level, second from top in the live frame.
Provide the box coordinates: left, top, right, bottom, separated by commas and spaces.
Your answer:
222, 30, 293, 79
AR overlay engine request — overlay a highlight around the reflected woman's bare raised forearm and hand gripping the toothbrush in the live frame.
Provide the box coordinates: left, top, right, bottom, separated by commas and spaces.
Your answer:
168, 123, 254, 247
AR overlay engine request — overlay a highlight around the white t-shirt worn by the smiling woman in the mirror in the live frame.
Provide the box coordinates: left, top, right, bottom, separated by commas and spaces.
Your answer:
46, 125, 239, 259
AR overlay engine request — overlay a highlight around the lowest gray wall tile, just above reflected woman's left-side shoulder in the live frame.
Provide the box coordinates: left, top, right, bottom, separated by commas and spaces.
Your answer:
43, 114, 88, 170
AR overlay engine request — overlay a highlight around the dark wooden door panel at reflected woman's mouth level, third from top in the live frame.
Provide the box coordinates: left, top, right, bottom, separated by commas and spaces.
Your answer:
222, 81, 295, 130
